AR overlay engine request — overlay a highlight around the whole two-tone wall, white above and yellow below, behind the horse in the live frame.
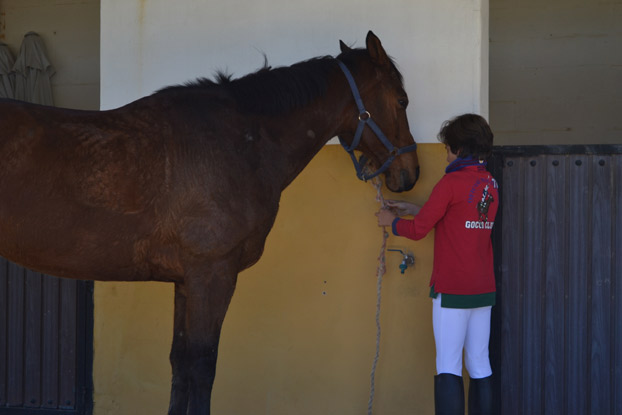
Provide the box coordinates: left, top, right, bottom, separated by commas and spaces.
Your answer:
94, 0, 488, 415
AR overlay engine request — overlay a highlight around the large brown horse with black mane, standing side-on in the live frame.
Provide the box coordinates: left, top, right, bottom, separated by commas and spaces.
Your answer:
0, 32, 419, 415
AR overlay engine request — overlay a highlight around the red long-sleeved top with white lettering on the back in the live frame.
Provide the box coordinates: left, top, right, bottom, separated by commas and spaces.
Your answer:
393, 166, 499, 295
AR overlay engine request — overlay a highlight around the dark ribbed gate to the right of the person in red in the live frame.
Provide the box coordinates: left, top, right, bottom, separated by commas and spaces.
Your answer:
491, 146, 622, 415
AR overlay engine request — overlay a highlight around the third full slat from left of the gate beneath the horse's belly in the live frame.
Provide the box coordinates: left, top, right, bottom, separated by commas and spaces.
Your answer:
41, 276, 60, 408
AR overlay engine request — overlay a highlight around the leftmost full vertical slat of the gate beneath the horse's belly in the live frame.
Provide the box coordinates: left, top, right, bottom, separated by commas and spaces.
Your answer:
7, 263, 24, 406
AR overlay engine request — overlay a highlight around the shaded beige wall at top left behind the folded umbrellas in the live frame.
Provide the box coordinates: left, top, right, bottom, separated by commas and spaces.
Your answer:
0, 0, 100, 109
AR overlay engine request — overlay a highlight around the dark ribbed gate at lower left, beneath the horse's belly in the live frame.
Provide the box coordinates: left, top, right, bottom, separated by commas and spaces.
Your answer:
0, 258, 93, 415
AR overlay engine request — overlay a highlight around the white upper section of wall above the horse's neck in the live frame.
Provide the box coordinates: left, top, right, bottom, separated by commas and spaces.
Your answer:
101, 0, 488, 142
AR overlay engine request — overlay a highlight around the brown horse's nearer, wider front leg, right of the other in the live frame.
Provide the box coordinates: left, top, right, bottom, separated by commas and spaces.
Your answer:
184, 264, 237, 415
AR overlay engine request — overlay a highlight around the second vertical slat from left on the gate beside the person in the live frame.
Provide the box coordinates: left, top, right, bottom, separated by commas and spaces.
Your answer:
521, 157, 546, 415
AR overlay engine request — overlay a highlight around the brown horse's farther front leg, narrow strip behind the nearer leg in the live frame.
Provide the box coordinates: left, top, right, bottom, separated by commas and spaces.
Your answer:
168, 283, 188, 415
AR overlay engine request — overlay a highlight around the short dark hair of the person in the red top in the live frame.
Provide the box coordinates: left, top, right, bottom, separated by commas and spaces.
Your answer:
438, 114, 494, 160
